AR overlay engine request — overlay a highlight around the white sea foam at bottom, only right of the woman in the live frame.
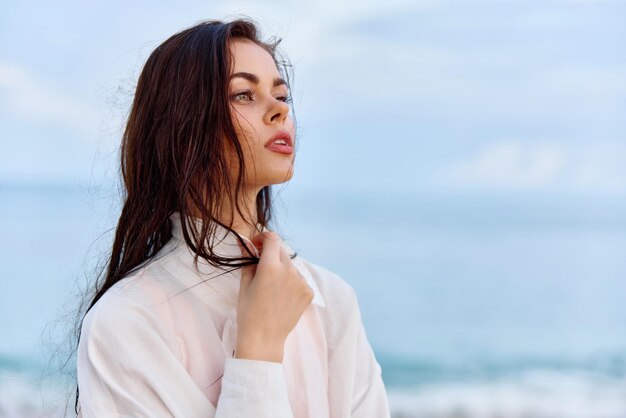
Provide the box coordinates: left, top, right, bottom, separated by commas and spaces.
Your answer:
388, 371, 626, 418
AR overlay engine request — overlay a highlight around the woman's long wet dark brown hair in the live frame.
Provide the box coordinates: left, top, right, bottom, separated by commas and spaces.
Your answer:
74, 18, 293, 413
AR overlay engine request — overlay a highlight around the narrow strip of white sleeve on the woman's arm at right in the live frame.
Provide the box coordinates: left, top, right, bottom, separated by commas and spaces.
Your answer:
350, 295, 390, 418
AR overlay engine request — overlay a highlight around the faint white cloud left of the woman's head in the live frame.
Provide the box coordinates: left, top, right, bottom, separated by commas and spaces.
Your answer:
0, 62, 102, 142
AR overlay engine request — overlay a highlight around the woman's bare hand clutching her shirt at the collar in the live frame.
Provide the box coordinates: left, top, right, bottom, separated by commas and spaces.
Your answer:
235, 231, 313, 363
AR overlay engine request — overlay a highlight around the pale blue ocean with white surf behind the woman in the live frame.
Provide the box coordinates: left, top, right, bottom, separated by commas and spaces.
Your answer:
0, 184, 626, 418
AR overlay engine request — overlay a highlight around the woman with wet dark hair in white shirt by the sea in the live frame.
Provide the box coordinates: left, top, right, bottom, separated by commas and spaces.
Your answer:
76, 19, 389, 418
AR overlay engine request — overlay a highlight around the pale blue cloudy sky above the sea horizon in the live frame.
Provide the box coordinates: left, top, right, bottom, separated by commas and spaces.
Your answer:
0, 0, 626, 197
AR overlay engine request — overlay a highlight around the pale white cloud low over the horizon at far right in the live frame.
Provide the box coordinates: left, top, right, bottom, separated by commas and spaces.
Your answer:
434, 138, 626, 194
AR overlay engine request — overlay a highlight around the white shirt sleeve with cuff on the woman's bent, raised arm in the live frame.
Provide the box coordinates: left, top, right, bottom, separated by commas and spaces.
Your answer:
77, 295, 293, 418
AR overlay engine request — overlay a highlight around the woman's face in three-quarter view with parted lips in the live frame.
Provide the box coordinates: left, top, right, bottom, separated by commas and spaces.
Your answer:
229, 40, 295, 189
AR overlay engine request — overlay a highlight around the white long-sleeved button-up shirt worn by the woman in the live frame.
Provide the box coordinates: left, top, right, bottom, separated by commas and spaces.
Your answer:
77, 212, 390, 418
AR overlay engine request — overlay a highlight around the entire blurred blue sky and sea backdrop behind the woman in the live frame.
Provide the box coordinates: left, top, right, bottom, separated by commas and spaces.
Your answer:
0, 0, 626, 418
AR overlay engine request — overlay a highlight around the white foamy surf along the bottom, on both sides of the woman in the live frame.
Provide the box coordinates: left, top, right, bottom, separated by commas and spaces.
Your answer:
0, 371, 626, 418
